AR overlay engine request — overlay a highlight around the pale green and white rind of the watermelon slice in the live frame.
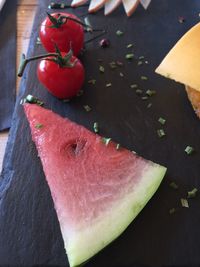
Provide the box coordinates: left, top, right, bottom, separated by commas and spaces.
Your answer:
61, 163, 166, 267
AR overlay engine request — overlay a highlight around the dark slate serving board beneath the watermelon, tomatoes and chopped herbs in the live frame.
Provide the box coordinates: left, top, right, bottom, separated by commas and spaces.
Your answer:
0, 0, 200, 267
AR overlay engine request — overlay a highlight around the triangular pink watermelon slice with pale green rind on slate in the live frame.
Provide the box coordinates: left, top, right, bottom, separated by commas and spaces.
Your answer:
24, 104, 166, 267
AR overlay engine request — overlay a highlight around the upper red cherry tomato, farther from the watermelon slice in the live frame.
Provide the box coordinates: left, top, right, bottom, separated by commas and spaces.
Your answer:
39, 13, 84, 56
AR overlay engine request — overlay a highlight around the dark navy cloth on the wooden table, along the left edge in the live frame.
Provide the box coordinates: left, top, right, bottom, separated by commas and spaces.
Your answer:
0, 0, 17, 131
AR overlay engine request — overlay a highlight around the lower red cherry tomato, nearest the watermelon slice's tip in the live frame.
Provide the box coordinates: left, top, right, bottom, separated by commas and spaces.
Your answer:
37, 53, 85, 99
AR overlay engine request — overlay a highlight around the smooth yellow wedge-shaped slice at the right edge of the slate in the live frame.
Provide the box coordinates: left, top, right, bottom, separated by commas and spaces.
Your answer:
156, 23, 200, 92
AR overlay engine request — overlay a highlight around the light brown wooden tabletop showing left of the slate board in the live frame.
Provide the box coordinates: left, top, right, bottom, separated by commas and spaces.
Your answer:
0, 0, 37, 171
